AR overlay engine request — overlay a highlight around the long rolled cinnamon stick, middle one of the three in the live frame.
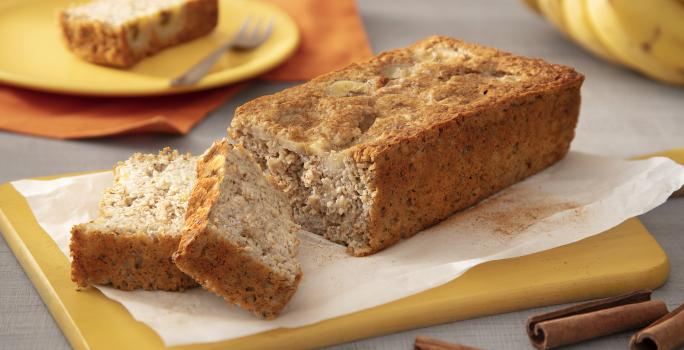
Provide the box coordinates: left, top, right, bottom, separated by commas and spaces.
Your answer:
527, 290, 667, 349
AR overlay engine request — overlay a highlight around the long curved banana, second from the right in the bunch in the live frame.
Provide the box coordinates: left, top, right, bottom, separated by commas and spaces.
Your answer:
576, 0, 684, 85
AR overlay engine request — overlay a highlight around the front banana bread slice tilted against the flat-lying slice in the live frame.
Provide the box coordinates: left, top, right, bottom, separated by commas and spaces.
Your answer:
174, 140, 302, 319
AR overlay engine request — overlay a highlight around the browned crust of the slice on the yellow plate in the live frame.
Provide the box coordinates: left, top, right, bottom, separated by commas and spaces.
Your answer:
59, 0, 218, 68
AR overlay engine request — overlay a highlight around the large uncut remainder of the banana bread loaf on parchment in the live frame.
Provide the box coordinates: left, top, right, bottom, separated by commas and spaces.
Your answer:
229, 37, 583, 255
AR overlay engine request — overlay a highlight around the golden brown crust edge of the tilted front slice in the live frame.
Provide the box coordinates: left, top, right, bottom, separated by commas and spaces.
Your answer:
173, 140, 301, 319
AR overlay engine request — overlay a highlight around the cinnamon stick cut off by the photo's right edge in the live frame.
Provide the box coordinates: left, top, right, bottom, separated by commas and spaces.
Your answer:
629, 305, 684, 350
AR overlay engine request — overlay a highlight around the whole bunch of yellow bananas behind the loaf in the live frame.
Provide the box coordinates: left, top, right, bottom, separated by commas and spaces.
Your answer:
523, 0, 684, 85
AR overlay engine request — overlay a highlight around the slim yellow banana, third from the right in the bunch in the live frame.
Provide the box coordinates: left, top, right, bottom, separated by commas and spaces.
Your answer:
561, 0, 618, 63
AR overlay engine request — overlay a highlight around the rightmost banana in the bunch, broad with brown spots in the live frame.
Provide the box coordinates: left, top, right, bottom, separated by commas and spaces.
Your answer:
611, 0, 684, 71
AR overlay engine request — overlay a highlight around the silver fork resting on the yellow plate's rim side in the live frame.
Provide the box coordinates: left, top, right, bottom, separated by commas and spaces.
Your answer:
171, 16, 273, 86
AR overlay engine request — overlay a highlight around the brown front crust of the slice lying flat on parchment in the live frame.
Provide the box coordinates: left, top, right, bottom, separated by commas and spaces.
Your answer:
69, 225, 197, 291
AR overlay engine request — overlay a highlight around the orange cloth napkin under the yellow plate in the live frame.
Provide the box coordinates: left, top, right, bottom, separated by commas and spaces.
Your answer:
0, 0, 372, 139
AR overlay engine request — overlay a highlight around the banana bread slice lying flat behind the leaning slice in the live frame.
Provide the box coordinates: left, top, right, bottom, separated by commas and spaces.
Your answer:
70, 148, 197, 291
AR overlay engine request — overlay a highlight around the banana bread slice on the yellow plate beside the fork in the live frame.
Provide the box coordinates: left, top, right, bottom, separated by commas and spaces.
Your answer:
59, 0, 218, 68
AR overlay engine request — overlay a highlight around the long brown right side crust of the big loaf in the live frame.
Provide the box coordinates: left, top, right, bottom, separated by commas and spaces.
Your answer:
360, 81, 581, 255
